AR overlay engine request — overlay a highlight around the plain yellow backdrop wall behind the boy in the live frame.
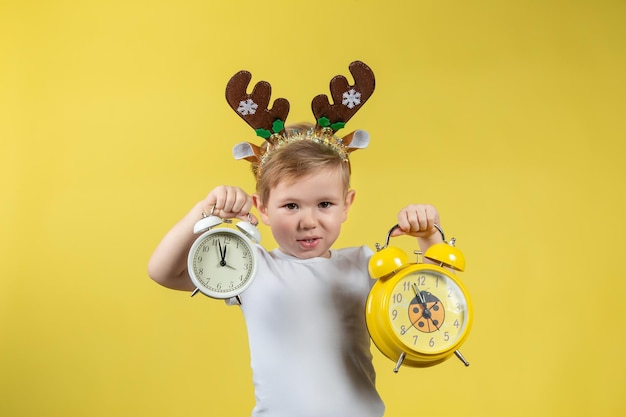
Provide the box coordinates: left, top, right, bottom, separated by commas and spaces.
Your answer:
0, 0, 626, 417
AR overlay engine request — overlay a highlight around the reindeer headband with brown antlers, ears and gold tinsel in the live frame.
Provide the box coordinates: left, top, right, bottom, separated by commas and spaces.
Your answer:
226, 61, 375, 176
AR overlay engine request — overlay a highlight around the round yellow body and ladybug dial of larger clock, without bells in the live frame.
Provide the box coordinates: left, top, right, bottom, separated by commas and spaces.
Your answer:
366, 264, 472, 367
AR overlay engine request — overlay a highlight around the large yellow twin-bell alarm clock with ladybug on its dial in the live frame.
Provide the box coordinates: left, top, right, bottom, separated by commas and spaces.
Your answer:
365, 225, 473, 372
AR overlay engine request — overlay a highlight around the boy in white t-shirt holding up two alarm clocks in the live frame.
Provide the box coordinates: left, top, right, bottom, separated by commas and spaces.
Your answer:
148, 62, 441, 417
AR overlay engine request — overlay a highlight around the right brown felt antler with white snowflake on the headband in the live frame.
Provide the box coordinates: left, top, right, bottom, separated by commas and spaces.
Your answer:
311, 61, 376, 132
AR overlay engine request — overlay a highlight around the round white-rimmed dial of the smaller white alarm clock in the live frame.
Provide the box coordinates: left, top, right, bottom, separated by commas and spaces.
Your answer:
187, 229, 256, 299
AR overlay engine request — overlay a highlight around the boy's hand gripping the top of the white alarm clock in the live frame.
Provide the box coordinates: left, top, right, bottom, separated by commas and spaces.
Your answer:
201, 185, 258, 224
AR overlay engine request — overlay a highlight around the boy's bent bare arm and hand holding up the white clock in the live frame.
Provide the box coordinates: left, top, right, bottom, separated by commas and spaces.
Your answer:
148, 185, 252, 291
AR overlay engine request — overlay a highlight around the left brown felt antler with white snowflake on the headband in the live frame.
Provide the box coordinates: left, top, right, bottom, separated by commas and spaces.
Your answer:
226, 71, 289, 139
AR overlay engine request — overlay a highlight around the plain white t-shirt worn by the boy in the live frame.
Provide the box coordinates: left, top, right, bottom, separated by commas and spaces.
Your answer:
232, 246, 385, 417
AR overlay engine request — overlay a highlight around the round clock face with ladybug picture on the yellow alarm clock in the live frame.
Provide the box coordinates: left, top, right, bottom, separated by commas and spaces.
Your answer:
389, 270, 468, 353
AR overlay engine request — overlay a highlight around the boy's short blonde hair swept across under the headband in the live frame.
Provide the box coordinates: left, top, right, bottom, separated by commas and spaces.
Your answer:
252, 124, 350, 204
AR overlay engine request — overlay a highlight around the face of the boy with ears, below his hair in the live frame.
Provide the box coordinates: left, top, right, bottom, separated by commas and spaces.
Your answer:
254, 170, 355, 259
